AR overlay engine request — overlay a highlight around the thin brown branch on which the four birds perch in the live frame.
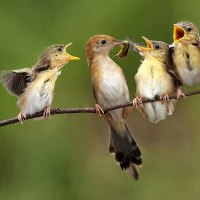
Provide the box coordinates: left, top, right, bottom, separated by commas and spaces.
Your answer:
0, 90, 200, 126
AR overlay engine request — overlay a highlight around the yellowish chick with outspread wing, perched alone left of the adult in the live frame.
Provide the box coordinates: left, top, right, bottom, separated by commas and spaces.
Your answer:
0, 43, 79, 123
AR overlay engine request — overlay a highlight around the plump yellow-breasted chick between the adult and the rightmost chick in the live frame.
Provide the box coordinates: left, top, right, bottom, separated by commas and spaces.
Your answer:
133, 37, 181, 123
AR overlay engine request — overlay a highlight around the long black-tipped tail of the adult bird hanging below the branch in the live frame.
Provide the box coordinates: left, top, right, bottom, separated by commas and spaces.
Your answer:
109, 121, 142, 180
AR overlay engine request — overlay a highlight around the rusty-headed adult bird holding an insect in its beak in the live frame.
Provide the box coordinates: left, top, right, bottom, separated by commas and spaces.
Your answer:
86, 35, 142, 180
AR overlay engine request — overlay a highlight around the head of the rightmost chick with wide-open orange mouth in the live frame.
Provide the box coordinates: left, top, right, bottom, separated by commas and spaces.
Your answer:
173, 21, 199, 44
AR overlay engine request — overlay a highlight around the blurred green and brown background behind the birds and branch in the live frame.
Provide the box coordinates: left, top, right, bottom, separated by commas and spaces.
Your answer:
0, 0, 200, 200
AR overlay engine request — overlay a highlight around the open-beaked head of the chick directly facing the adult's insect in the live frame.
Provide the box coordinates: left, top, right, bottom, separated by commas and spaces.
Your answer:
135, 36, 170, 62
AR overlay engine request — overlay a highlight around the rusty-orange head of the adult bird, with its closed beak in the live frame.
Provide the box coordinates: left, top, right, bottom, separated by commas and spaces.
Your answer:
86, 35, 123, 62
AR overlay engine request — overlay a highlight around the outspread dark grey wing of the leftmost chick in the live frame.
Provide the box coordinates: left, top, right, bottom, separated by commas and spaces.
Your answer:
0, 68, 33, 96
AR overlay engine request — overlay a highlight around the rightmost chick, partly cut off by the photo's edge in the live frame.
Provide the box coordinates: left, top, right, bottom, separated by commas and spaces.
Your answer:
170, 21, 200, 85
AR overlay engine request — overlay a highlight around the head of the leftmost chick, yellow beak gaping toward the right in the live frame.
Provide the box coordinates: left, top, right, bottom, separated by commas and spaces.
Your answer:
39, 43, 80, 69
